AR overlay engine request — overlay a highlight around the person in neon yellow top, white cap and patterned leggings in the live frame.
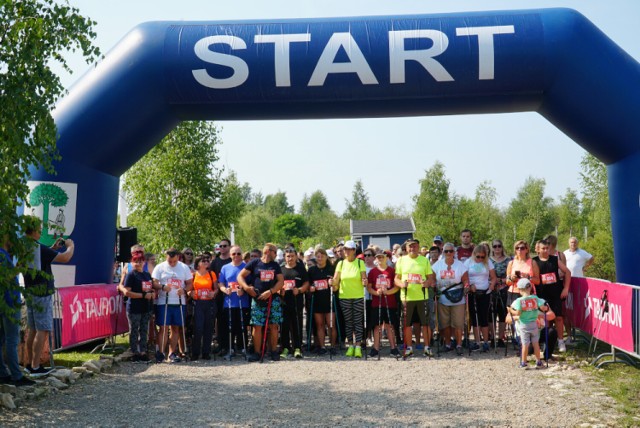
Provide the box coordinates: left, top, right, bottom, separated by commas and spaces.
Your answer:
333, 241, 367, 358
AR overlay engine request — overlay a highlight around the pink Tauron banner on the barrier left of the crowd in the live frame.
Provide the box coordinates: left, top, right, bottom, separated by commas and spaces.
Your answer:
57, 284, 129, 348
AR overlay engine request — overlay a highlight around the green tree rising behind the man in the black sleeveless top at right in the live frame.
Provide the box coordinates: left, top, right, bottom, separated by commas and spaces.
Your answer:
505, 177, 555, 247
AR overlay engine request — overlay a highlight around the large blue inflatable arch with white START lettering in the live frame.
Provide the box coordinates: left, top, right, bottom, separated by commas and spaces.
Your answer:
31, 9, 640, 284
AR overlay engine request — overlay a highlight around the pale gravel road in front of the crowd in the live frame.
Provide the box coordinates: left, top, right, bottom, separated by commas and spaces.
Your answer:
0, 351, 618, 427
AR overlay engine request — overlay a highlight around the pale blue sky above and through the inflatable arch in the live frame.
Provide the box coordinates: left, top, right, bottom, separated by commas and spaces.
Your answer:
59, 0, 640, 213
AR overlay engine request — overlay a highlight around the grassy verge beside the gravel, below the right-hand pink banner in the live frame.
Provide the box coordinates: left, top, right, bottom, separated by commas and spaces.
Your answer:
561, 343, 640, 427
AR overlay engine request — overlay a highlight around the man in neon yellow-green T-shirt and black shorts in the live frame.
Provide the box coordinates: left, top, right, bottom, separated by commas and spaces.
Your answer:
395, 239, 435, 357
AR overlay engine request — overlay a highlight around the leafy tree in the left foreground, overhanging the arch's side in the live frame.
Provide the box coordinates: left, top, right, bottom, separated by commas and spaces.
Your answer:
0, 0, 99, 313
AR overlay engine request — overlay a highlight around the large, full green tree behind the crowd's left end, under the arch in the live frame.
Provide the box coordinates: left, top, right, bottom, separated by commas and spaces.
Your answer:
123, 122, 239, 252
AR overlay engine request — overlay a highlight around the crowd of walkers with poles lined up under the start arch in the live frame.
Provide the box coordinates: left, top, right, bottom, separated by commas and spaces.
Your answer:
114, 230, 593, 367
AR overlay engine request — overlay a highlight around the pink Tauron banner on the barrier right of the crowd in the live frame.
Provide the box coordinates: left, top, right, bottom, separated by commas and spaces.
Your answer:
563, 278, 634, 352
